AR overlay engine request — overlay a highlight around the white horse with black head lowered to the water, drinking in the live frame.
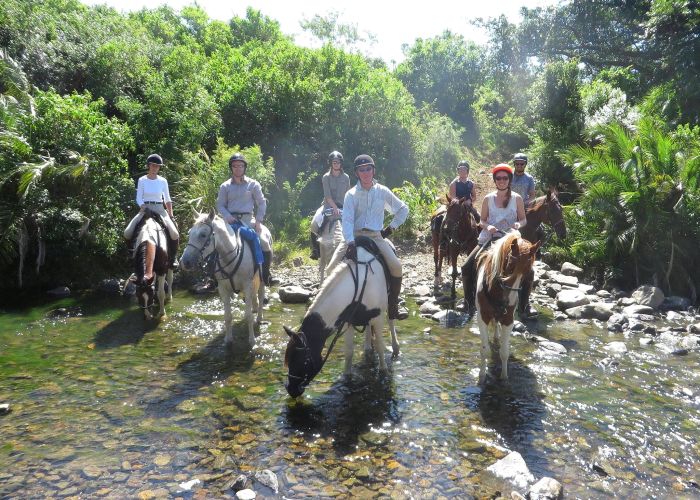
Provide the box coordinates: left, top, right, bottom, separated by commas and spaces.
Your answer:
284, 237, 399, 397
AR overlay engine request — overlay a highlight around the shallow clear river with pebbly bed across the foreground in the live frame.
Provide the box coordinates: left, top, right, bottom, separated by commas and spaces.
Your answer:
0, 292, 700, 498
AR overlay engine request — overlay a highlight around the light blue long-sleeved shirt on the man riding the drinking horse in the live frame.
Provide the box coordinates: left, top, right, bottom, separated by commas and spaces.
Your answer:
343, 181, 408, 242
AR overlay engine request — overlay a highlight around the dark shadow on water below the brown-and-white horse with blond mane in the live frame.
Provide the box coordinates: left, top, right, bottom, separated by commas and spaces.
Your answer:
463, 357, 549, 476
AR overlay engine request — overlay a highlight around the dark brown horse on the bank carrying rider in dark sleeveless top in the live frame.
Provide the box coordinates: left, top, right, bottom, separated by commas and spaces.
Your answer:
431, 196, 479, 299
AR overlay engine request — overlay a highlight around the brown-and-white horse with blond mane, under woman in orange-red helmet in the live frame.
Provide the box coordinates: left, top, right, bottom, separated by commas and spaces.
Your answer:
476, 231, 540, 384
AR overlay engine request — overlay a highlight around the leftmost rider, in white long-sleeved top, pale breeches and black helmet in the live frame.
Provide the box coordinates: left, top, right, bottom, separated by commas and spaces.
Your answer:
124, 154, 180, 282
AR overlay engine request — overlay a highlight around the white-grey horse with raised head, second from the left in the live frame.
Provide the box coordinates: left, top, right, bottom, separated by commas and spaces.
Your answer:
180, 209, 272, 347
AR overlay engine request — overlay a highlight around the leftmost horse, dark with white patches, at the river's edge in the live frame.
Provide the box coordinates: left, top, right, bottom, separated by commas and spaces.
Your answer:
127, 209, 173, 321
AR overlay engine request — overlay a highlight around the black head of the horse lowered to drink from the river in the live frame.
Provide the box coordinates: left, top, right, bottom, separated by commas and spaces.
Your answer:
284, 326, 322, 398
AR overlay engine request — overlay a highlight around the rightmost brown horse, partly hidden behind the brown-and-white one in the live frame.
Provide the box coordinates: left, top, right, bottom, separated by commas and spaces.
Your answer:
518, 188, 566, 319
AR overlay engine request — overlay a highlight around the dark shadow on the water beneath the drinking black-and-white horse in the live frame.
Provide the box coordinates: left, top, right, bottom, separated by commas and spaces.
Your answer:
284, 361, 401, 455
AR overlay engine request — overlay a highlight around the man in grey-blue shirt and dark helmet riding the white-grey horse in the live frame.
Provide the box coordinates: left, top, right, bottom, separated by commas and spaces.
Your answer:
216, 153, 272, 286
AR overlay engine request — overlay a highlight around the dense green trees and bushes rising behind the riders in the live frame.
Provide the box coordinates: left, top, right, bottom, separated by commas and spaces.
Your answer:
0, 0, 700, 300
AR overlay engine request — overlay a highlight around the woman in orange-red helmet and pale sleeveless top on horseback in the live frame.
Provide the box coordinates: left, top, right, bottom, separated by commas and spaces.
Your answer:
462, 163, 527, 312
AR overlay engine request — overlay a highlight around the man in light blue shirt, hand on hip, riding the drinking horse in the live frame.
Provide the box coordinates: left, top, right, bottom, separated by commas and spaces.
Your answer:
327, 155, 408, 319
